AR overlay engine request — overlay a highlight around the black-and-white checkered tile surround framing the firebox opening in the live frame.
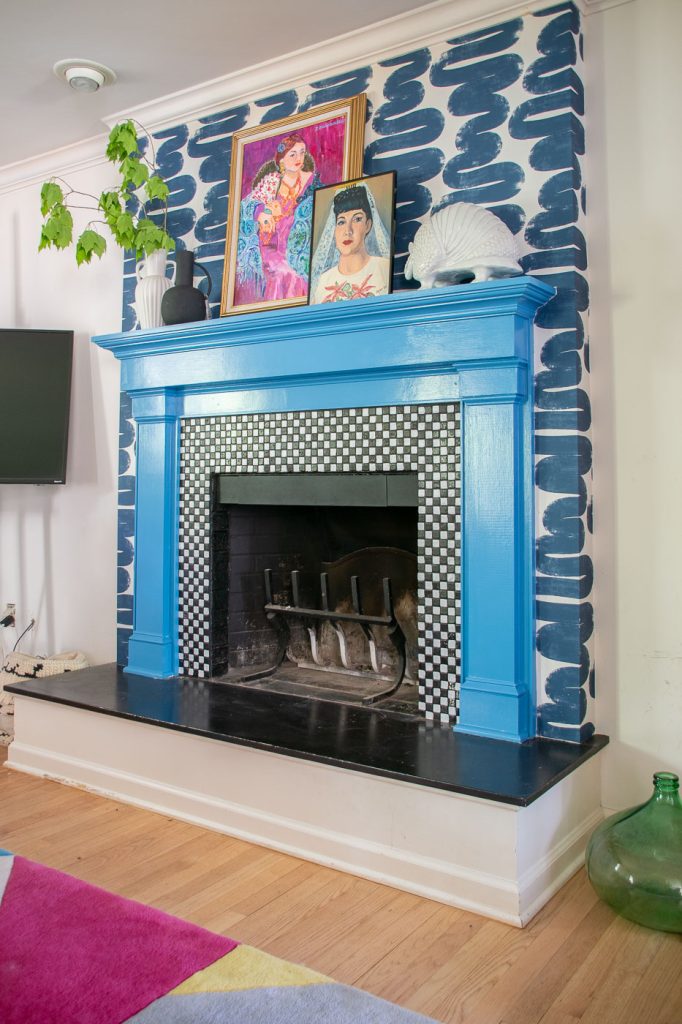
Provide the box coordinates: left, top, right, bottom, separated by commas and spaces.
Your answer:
179, 403, 461, 722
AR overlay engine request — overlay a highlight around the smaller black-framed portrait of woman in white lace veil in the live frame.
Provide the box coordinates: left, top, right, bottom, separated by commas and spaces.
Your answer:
308, 171, 395, 305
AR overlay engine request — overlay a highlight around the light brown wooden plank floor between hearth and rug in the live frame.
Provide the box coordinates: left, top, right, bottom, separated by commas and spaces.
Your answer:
0, 748, 682, 1024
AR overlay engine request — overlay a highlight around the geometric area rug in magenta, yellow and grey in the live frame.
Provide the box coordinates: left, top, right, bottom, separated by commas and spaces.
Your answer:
0, 850, 436, 1024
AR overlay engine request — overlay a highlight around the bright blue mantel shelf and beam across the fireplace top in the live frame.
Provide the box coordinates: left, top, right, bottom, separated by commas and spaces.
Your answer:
93, 278, 554, 416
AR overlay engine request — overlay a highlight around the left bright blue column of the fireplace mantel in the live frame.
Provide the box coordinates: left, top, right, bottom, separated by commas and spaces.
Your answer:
126, 389, 182, 679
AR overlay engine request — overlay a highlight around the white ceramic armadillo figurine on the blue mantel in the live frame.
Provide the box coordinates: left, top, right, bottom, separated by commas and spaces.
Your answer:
404, 203, 523, 288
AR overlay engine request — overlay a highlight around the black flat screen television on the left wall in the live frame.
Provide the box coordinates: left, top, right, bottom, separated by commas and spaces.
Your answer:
0, 329, 74, 483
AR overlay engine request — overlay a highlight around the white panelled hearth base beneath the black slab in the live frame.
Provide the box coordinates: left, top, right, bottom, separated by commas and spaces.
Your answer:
7, 694, 602, 927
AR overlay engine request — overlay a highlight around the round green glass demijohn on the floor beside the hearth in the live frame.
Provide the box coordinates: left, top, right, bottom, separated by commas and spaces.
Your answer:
587, 771, 682, 932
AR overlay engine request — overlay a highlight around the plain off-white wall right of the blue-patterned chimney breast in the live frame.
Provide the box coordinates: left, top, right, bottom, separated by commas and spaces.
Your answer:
587, 0, 682, 808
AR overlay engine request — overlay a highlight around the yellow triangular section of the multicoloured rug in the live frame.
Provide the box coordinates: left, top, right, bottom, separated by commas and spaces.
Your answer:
168, 946, 330, 995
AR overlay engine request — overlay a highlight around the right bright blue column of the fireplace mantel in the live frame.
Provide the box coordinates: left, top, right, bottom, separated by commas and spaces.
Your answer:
456, 393, 536, 742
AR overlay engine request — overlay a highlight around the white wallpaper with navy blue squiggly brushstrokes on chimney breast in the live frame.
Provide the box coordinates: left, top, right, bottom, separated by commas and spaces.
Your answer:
118, 3, 594, 741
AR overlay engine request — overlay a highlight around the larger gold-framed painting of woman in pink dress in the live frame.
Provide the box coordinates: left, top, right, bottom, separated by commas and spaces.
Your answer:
220, 94, 366, 316
